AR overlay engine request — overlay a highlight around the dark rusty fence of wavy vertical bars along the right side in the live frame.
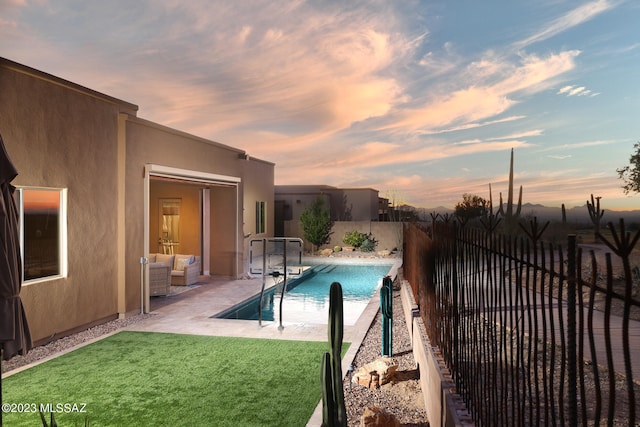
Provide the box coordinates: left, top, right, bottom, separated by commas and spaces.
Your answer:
403, 221, 640, 426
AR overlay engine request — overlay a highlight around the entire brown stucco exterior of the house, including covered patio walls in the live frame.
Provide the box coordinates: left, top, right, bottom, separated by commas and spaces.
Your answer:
0, 58, 274, 342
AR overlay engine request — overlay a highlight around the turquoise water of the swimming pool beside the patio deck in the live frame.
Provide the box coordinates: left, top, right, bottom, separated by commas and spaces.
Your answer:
215, 264, 391, 325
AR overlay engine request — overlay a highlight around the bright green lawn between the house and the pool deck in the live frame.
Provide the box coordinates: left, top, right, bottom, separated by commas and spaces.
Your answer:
2, 332, 348, 427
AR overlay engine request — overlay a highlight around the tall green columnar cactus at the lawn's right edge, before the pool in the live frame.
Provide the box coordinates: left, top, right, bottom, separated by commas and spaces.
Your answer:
320, 282, 347, 427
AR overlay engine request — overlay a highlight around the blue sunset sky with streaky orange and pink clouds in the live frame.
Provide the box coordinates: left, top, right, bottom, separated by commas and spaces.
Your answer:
0, 0, 640, 209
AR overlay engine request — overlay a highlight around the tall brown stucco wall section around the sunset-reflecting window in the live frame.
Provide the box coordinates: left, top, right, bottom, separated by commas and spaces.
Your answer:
0, 59, 137, 341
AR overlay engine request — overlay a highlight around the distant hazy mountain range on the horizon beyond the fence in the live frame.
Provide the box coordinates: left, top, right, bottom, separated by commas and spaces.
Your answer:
418, 203, 640, 224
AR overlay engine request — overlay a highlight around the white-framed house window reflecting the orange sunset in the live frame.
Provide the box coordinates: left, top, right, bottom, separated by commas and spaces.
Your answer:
18, 188, 67, 282
